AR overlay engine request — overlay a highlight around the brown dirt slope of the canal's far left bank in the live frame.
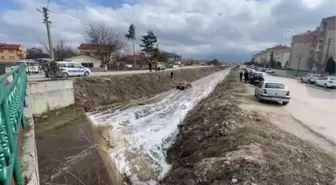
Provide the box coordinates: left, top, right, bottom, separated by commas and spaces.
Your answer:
74, 67, 223, 111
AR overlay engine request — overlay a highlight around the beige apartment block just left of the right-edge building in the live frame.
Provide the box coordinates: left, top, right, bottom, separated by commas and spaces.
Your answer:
288, 30, 319, 70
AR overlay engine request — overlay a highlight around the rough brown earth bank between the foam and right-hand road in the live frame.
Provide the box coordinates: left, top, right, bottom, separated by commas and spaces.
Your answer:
162, 69, 336, 185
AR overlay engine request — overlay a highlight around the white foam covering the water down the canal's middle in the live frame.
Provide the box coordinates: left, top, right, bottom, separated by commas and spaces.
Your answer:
90, 69, 230, 185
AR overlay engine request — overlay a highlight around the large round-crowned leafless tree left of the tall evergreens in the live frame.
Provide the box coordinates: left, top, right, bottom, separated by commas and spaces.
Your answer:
85, 24, 126, 69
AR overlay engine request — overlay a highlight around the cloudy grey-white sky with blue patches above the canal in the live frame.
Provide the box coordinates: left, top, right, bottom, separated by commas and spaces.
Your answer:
0, 0, 336, 61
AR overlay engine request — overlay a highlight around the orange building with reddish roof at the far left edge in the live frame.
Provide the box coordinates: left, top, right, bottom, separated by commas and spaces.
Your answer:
0, 43, 26, 65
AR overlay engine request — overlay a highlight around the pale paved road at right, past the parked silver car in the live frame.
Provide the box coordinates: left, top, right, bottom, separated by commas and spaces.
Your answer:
265, 75, 336, 144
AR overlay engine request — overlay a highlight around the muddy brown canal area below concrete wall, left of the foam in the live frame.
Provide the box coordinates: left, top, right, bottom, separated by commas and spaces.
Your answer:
35, 107, 113, 185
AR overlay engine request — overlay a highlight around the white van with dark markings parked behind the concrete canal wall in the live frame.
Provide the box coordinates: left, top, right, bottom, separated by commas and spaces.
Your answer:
57, 61, 91, 78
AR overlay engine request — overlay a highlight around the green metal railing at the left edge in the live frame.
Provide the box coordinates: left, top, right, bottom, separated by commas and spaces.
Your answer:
0, 65, 27, 185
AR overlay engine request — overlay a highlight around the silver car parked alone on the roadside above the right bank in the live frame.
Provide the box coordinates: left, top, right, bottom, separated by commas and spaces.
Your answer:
254, 81, 290, 105
